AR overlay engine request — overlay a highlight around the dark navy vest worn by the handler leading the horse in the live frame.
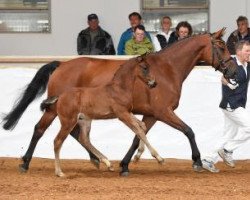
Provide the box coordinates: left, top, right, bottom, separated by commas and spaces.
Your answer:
220, 60, 250, 109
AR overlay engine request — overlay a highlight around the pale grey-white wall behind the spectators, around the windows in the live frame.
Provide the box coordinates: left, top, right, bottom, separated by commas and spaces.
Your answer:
0, 0, 250, 56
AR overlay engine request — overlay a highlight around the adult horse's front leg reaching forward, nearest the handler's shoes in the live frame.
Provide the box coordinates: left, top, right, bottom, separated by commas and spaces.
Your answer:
157, 109, 203, 172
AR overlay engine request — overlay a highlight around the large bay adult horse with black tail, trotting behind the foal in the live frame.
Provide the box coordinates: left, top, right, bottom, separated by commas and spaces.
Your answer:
3, 29, 236, 175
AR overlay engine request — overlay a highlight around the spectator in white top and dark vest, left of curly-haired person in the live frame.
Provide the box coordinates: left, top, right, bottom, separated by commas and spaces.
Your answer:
153, 16, 172, 51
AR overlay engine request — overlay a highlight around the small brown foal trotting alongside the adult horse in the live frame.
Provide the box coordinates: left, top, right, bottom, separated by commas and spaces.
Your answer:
41, 56, 164, 177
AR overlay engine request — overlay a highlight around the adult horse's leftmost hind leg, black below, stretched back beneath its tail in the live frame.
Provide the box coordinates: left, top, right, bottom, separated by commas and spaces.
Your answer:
19, 110, 57, 172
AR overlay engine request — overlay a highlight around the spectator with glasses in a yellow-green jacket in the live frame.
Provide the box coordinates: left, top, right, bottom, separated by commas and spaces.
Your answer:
125, 25, 154, 55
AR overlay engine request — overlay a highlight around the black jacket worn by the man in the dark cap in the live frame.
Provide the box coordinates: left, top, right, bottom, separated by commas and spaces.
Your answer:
77, 27, 115, 55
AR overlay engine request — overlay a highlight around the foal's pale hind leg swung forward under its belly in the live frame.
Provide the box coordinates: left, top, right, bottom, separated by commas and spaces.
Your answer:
78, 117, 114, 171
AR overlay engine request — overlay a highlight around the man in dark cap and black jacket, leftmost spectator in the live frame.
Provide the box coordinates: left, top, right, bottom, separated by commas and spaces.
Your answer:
77, 14, 115, 55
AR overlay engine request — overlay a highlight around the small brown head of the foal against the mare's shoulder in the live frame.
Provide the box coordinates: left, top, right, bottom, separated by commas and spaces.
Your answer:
136, 55, 157, 88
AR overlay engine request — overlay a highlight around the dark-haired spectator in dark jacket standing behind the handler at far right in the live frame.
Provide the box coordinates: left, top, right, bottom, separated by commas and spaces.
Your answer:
227, 16, 250, 55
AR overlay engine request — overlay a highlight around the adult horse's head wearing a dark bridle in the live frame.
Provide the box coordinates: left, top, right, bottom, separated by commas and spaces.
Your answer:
211, 28, 237, 79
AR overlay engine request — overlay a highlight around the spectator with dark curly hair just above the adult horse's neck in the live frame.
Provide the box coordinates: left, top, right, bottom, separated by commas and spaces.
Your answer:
168, 21, 193, 44
